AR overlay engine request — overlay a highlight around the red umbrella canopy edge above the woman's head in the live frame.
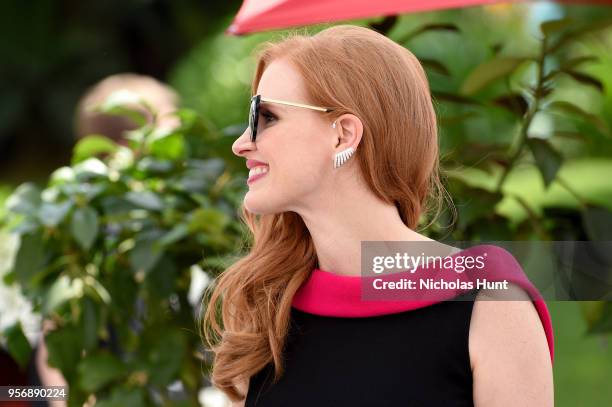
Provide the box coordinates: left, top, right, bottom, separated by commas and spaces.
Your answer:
226, 0, 612, 35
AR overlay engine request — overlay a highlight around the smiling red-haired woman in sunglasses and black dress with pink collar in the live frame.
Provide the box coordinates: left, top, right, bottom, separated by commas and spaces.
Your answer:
204, 25, 553, 406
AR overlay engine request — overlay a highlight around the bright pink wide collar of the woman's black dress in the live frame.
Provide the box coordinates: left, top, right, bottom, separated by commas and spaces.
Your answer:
292, 244, 554, 360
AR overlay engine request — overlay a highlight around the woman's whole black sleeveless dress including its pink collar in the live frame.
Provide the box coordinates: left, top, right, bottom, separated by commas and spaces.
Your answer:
245, 245, 554, 407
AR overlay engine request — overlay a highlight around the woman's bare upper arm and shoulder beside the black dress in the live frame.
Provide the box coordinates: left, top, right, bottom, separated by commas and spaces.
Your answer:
469, 283, 554, 406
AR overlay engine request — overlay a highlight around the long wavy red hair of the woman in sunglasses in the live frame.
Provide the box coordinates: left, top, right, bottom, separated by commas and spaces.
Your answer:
202, 25, 448, 401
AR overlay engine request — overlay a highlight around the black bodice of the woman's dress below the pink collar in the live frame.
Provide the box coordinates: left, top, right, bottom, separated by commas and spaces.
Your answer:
245, 289, 477, 407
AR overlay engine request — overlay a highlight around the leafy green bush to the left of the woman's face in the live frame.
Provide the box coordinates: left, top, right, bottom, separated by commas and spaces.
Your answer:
4, 93, 245, 406
